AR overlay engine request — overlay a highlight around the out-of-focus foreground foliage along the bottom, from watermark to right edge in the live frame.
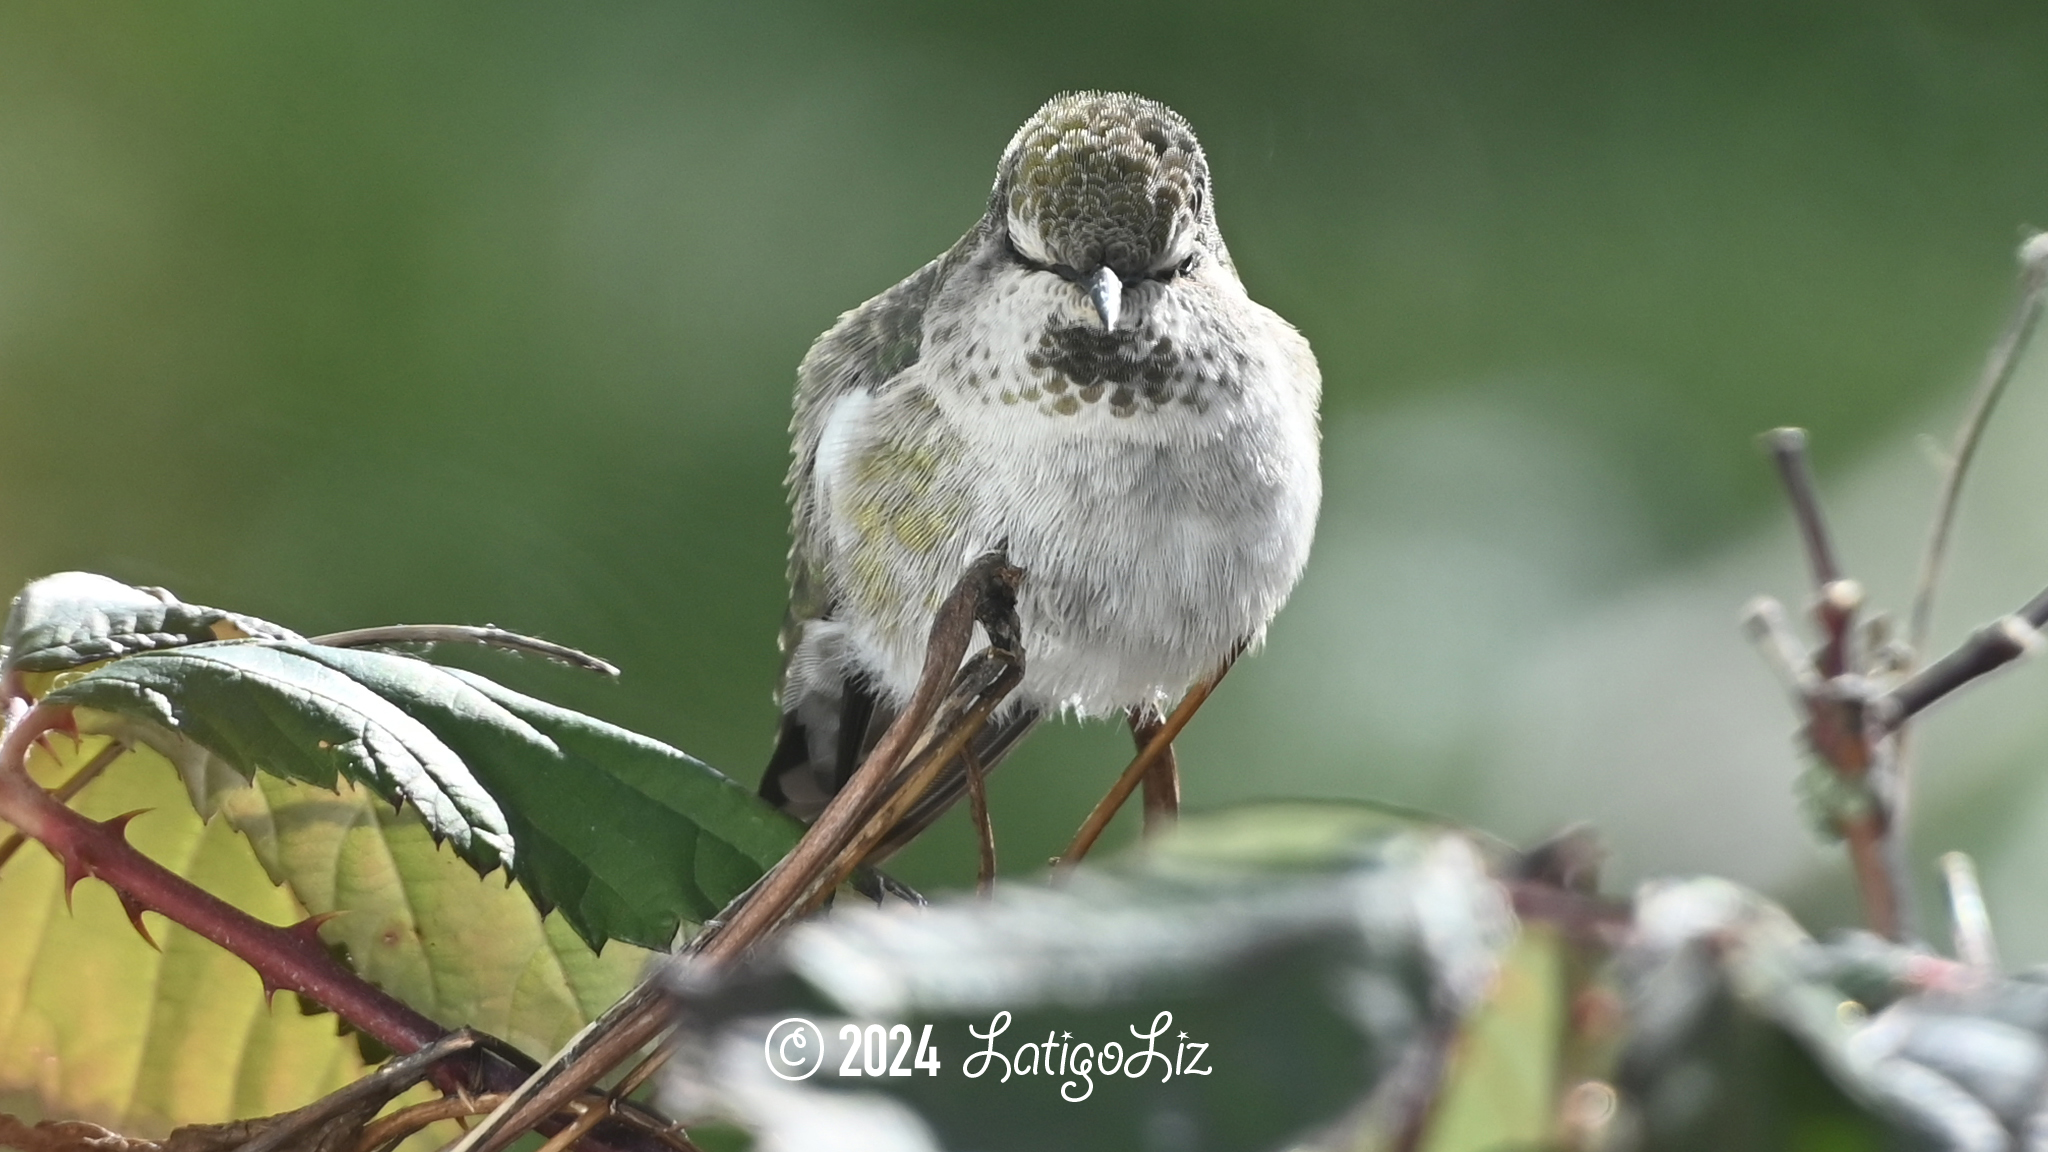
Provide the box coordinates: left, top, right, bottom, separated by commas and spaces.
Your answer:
664, 806, 2048, 1152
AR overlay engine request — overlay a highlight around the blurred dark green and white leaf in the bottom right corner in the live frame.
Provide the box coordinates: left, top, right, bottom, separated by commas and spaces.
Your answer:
1616, 879, 1998, 1152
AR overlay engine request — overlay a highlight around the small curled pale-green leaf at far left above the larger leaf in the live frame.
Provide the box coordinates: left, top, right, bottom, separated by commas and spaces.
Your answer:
0, 572, 297, 672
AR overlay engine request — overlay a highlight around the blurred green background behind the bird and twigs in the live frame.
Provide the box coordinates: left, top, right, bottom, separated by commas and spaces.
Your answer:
0, 0, 2048, 947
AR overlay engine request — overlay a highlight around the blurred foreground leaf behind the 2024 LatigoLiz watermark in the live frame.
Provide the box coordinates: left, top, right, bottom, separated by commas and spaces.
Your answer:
666, 806, 1511, 1150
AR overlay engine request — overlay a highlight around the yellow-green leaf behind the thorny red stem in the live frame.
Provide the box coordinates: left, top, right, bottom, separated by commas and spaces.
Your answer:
0, 738, 362, 1136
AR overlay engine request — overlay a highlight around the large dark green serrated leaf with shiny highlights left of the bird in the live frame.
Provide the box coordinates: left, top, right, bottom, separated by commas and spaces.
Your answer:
45, 642, 801, 947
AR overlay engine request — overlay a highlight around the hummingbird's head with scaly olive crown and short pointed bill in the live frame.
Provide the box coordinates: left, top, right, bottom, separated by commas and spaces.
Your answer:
991, 92, 1221, 330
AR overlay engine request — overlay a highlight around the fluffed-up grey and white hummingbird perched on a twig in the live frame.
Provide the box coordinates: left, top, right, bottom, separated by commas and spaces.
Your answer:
760, 92, 1321, 855
